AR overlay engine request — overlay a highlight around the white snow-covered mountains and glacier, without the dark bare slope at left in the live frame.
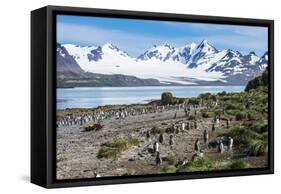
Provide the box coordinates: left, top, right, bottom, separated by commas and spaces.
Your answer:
57, 40, 268, 84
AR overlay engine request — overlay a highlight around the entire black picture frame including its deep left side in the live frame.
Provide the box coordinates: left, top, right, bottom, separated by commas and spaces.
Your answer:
31, 6, 274, 188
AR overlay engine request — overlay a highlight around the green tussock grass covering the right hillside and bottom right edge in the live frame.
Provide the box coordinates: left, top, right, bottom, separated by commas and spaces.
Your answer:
158, 80, 268, 173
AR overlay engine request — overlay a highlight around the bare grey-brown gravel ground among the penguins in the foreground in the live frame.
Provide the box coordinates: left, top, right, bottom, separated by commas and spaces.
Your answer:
57, 110, 267, 179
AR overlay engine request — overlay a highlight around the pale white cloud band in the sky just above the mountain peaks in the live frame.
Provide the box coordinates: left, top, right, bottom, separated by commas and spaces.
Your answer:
57, 22, 267, 56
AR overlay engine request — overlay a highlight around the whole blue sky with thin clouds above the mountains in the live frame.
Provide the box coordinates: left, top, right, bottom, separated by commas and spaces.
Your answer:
57, 15, 268, 57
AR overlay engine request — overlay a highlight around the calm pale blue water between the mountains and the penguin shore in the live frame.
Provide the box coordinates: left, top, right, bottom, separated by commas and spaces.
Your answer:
57, 86, 245, 109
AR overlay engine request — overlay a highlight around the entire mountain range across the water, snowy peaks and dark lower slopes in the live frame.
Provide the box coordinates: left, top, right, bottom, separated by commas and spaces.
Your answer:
57, 40, 268, 86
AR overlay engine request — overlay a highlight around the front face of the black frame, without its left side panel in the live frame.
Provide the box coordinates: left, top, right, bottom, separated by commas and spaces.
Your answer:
35, 6, 274, 188
